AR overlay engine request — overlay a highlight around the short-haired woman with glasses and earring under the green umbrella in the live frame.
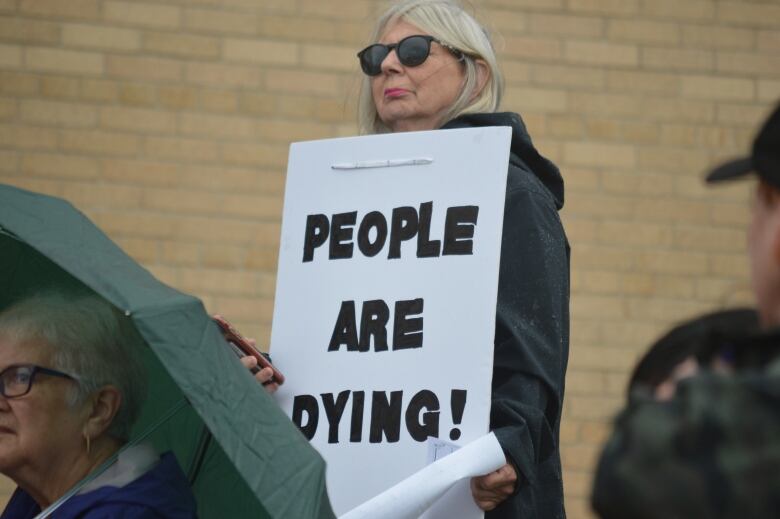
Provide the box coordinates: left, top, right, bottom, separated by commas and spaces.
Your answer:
0, 293, 196, 519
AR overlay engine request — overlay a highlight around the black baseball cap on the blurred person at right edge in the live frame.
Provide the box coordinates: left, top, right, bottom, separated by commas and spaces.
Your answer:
707, 101, 780, 189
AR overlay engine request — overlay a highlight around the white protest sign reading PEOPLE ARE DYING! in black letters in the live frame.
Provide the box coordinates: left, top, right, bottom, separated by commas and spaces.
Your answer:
271, 127, 511, 518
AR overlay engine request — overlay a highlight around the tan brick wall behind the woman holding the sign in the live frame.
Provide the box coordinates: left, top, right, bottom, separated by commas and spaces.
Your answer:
0, 0, 780, 519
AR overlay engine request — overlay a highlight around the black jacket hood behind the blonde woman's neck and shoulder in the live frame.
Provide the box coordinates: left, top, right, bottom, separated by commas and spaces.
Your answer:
442, 112, 563, 209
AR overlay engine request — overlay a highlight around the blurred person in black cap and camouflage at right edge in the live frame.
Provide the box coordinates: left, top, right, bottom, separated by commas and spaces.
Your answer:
591, 106, 780, 519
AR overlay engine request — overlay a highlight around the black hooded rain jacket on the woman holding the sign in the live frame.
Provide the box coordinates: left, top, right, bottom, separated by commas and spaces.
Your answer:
443, 113, 570, 519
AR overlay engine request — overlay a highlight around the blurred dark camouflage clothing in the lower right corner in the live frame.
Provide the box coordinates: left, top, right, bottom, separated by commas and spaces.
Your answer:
592, 359, 780, 519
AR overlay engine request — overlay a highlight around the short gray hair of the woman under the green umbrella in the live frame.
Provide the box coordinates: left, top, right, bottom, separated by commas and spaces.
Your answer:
0, 291, 146, 441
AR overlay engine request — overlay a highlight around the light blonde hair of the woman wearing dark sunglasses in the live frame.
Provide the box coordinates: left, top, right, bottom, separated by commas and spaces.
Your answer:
358, 0, 504, 134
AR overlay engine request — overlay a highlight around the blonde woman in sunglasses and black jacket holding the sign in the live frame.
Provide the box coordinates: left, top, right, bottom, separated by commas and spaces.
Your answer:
358, 0, 569, 519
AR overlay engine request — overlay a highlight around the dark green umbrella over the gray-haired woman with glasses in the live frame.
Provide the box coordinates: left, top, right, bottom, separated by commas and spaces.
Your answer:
0, 184, 334, 519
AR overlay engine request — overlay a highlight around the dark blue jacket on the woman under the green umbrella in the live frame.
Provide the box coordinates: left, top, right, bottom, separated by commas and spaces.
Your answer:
0, 452, 197, 519
